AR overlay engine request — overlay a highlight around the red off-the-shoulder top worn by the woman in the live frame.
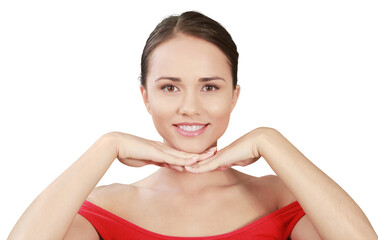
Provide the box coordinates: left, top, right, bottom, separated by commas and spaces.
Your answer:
79, 201, 305, 240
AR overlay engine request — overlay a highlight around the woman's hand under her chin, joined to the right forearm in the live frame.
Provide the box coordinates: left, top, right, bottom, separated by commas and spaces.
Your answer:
185, 127, 265, 173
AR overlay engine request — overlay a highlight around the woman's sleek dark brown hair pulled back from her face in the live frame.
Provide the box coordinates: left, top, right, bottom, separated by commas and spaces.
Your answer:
140, 11, 239, 88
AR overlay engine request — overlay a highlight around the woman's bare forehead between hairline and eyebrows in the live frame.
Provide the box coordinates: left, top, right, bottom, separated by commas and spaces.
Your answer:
147, 34, 232, 80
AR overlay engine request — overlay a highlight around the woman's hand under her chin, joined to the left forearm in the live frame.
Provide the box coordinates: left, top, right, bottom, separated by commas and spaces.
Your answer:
108, 132, 216, 172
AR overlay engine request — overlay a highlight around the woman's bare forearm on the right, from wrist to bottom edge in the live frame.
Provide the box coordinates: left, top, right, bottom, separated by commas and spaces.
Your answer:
259, 129, 376, 239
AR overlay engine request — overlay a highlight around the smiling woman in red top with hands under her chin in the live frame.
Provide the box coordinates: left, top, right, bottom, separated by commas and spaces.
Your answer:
9, 12, 377, 239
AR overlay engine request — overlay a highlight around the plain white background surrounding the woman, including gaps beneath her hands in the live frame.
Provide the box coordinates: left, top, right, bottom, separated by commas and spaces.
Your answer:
0, 0, 378, 236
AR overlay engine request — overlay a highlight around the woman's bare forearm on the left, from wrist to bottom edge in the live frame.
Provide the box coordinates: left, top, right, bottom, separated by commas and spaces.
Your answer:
9, 135, 117, 239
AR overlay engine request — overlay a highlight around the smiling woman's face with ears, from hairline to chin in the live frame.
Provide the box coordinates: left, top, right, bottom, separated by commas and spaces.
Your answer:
141, 34, 240, 153
